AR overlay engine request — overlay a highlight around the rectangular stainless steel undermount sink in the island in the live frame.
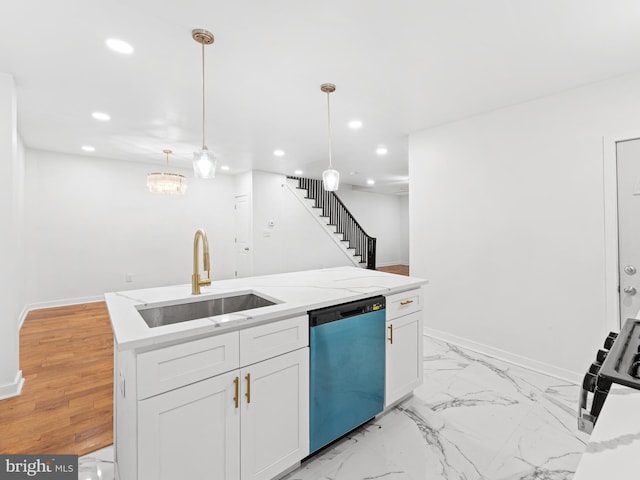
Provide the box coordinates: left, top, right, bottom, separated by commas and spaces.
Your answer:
136, 293, 275, 328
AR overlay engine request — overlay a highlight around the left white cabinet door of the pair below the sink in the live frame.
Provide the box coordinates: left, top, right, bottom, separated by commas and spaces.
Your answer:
138, 370, 240, 480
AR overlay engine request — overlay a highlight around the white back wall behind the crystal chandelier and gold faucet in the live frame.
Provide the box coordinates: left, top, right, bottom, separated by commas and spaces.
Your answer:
26, 150, 235, 304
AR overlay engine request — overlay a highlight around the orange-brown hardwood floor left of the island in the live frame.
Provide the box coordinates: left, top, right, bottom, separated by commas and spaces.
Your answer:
0, 302, 113, 455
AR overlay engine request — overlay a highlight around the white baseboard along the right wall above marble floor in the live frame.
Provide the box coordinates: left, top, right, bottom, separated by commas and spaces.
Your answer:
424, 327, 584, 385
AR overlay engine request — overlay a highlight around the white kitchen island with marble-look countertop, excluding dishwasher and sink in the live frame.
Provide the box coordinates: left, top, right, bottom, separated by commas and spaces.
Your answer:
105, 267, 426, 480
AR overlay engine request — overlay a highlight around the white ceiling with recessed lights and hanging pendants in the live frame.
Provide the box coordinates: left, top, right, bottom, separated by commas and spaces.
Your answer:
0, 0, 640, 192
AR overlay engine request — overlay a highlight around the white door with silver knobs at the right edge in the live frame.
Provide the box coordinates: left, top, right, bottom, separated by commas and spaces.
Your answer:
616, 139, 640, 324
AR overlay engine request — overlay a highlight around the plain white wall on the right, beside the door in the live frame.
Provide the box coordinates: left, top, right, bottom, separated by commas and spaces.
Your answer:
409, 74, 640, 380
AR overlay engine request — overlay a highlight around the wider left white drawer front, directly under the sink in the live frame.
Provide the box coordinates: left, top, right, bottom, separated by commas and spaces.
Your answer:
137, 332, 240, 400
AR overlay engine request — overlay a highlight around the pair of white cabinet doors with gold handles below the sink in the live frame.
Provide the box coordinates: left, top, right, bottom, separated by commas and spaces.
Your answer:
138, 348, 309, 480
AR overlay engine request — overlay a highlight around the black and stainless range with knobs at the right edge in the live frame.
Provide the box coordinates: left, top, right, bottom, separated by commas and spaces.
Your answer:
578, 318, 640, 433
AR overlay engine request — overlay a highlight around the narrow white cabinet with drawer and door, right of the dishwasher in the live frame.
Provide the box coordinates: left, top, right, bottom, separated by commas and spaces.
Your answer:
385, 290, 423, 407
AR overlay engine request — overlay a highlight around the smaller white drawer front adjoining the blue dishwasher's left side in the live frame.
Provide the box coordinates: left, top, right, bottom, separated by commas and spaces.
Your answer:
240, 315, 309, 366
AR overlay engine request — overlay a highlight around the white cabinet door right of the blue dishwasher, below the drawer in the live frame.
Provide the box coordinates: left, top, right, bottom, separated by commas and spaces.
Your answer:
385, 311, 423, 407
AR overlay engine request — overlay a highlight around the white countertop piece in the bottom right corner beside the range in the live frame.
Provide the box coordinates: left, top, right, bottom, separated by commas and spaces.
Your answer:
573, 384, 640, 480
